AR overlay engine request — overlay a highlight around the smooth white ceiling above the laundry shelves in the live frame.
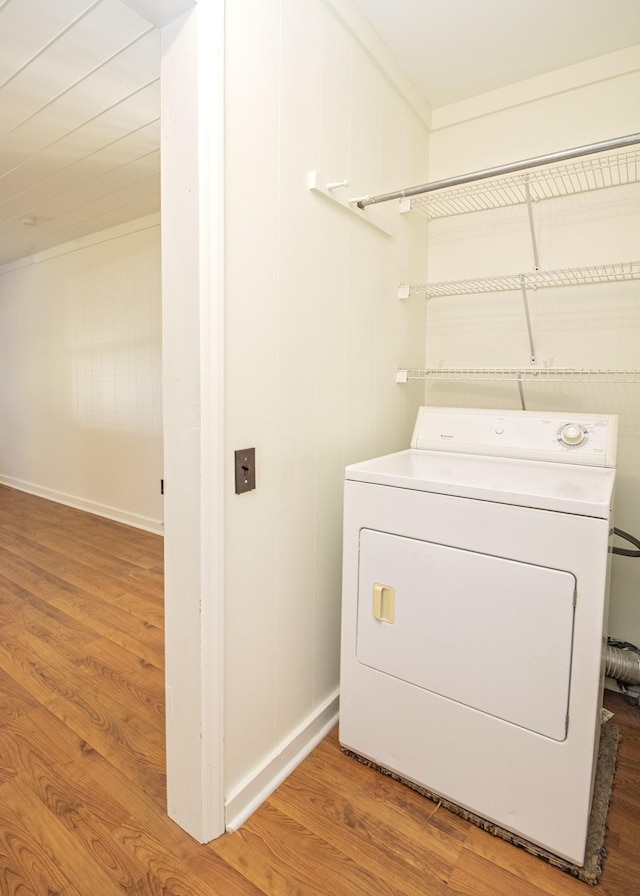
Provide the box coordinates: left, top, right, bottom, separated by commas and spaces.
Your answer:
355, 0, 640, 109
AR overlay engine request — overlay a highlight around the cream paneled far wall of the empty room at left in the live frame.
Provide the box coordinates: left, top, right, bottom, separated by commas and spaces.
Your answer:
0, 216, 162, 531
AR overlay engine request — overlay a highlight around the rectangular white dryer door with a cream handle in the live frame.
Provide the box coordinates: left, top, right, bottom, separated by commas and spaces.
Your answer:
356, 529, 576, 741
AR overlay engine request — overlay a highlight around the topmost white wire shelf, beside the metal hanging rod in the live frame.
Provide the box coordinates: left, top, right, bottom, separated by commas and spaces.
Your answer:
406, 147, 640, 220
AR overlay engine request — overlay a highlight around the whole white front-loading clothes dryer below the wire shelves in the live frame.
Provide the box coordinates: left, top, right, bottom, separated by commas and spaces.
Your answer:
340, 408, 617, 865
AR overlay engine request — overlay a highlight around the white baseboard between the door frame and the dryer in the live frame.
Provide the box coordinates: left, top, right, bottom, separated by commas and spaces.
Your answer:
225, 690, 339, 831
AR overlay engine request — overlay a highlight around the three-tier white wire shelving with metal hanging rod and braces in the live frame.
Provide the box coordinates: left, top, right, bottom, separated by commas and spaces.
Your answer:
380, 133, 640, 390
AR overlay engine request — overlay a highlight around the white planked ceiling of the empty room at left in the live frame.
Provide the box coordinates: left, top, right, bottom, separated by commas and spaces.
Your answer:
0, 0, 168, 264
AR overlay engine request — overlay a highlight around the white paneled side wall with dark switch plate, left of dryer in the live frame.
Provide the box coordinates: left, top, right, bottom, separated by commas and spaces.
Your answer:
225, 0, 428, 824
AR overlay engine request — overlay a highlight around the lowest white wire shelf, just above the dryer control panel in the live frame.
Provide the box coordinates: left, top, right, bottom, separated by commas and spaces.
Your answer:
396, 367, 640, 384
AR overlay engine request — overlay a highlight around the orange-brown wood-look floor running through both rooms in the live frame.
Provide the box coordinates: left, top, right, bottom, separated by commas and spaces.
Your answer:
0, 486, 640, 896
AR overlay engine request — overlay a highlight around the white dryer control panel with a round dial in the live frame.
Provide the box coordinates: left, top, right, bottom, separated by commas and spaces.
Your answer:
411, 407, 618, 467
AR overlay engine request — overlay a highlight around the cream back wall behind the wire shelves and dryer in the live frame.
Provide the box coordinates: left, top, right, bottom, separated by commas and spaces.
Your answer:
426, 47, 640, 644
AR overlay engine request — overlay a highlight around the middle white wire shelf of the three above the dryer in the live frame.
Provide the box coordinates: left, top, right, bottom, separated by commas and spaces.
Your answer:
399, 261, 640, 298
